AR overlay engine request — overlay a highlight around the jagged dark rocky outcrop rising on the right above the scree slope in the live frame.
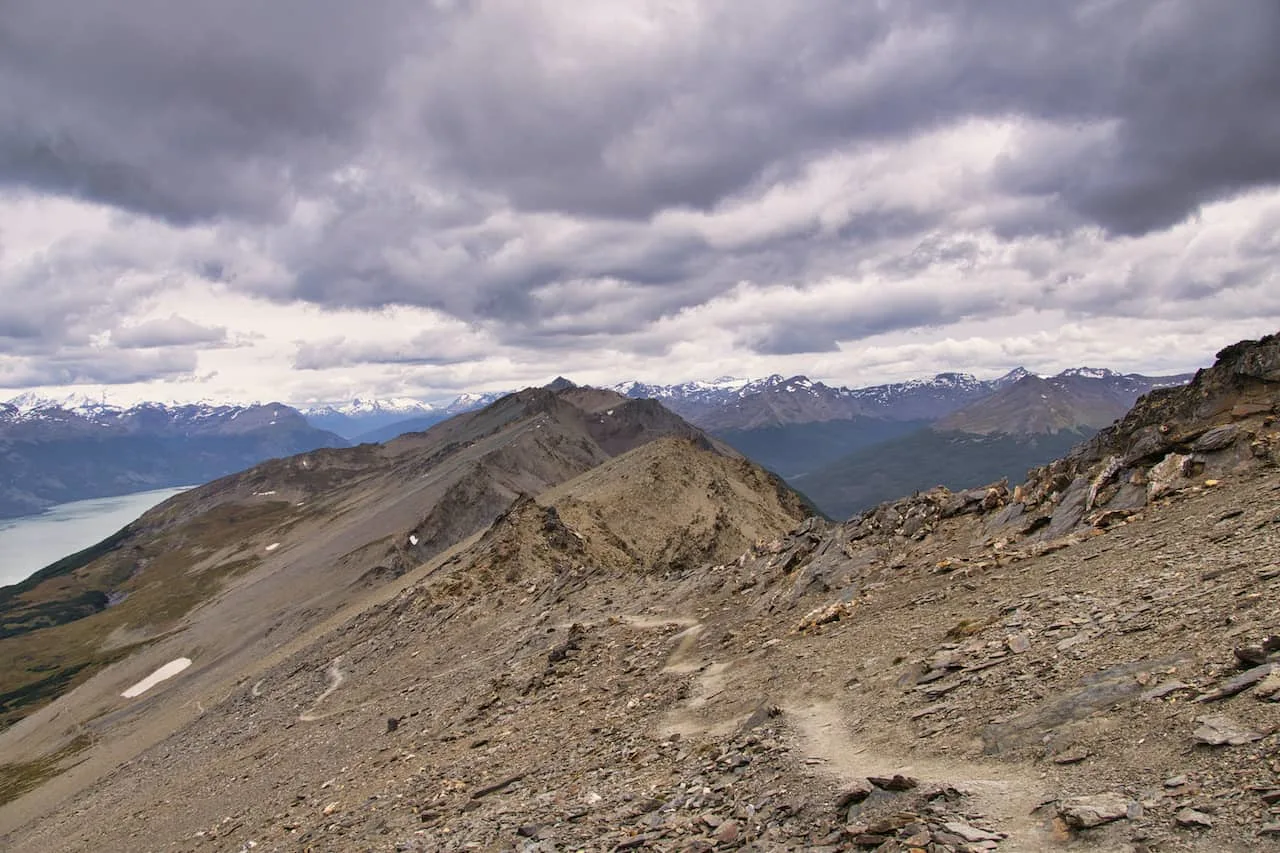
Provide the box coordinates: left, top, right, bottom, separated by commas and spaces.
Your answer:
824, 334, 1280, 550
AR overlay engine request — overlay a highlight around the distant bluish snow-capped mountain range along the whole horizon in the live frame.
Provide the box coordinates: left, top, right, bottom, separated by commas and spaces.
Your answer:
0, 368, 1188, 517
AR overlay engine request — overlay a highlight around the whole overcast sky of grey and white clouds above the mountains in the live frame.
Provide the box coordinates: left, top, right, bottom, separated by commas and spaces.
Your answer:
0, 0, 1280, 403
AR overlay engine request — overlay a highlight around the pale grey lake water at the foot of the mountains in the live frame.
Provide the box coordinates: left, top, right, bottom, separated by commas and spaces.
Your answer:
0, 487, 191, 587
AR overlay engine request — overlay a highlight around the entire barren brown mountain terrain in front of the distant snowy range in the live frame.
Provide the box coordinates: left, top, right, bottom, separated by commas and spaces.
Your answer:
0, 336, 1280, 853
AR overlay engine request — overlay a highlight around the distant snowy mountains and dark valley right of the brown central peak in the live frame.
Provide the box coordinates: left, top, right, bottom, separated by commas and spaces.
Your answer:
616, 368, 1190, 517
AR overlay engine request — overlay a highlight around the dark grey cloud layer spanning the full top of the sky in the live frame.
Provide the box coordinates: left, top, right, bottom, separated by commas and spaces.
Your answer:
10, 0, 1280, 232
